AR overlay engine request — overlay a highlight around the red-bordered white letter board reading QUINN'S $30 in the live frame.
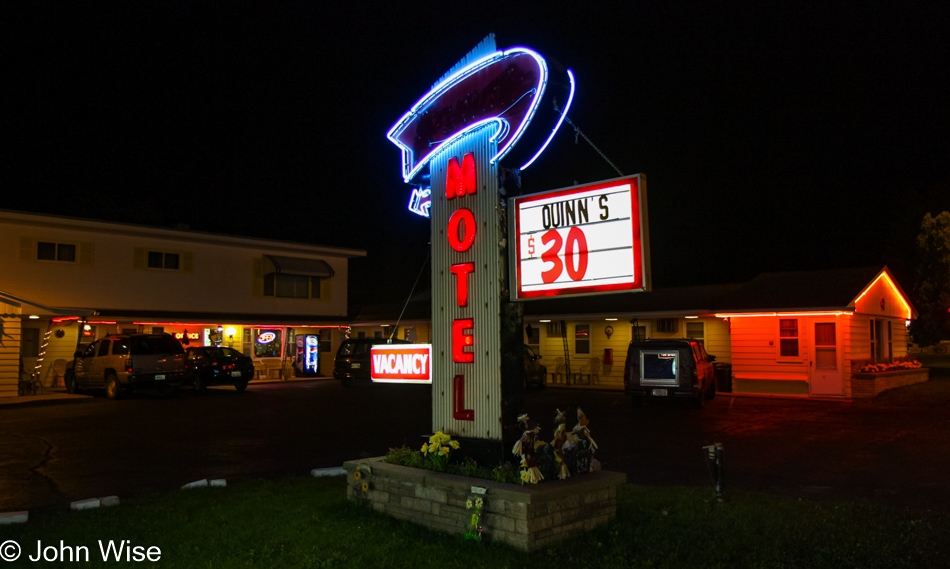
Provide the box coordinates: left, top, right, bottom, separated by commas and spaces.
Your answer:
510, 174, 650, 300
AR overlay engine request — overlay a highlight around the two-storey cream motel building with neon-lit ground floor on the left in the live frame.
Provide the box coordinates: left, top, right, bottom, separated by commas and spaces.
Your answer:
0, 206, 366, 397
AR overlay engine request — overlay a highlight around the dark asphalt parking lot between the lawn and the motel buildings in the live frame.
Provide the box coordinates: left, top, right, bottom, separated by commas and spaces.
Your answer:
0, 377, 950, 512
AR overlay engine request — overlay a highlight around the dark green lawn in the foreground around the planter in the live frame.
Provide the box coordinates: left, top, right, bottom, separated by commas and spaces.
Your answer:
0, 478, 950, 569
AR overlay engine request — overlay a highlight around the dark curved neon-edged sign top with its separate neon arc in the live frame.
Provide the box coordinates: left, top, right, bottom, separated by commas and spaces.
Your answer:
386, 47, 574, 182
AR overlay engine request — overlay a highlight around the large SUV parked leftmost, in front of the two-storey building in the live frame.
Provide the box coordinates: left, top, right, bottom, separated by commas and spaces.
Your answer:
65, 334, 185, 399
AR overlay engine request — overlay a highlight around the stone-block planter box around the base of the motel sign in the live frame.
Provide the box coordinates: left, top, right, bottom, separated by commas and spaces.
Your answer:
343, 457, 627, 551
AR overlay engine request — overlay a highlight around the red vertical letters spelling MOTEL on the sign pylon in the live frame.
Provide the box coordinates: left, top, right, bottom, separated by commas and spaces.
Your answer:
445, 152, 476, 421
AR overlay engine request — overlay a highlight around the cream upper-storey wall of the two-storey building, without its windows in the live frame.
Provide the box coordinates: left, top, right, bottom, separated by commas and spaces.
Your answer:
0, 214, 353, 316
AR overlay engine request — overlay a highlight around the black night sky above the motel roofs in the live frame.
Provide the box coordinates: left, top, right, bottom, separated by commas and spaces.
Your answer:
0, 0, 950, 308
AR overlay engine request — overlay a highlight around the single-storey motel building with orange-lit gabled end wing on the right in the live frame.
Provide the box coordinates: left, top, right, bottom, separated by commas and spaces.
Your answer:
353, 267, 926, 399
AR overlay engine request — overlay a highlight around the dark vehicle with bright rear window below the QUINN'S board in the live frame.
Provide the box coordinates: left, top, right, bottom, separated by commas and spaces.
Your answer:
623, 338, 716, 409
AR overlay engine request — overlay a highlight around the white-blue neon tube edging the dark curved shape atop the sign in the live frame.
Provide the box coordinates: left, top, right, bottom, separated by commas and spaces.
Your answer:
386, 47, 548, 182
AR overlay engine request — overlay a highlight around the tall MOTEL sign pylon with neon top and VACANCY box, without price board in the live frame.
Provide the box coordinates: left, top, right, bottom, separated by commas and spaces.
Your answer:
386, 37, 574, 434
